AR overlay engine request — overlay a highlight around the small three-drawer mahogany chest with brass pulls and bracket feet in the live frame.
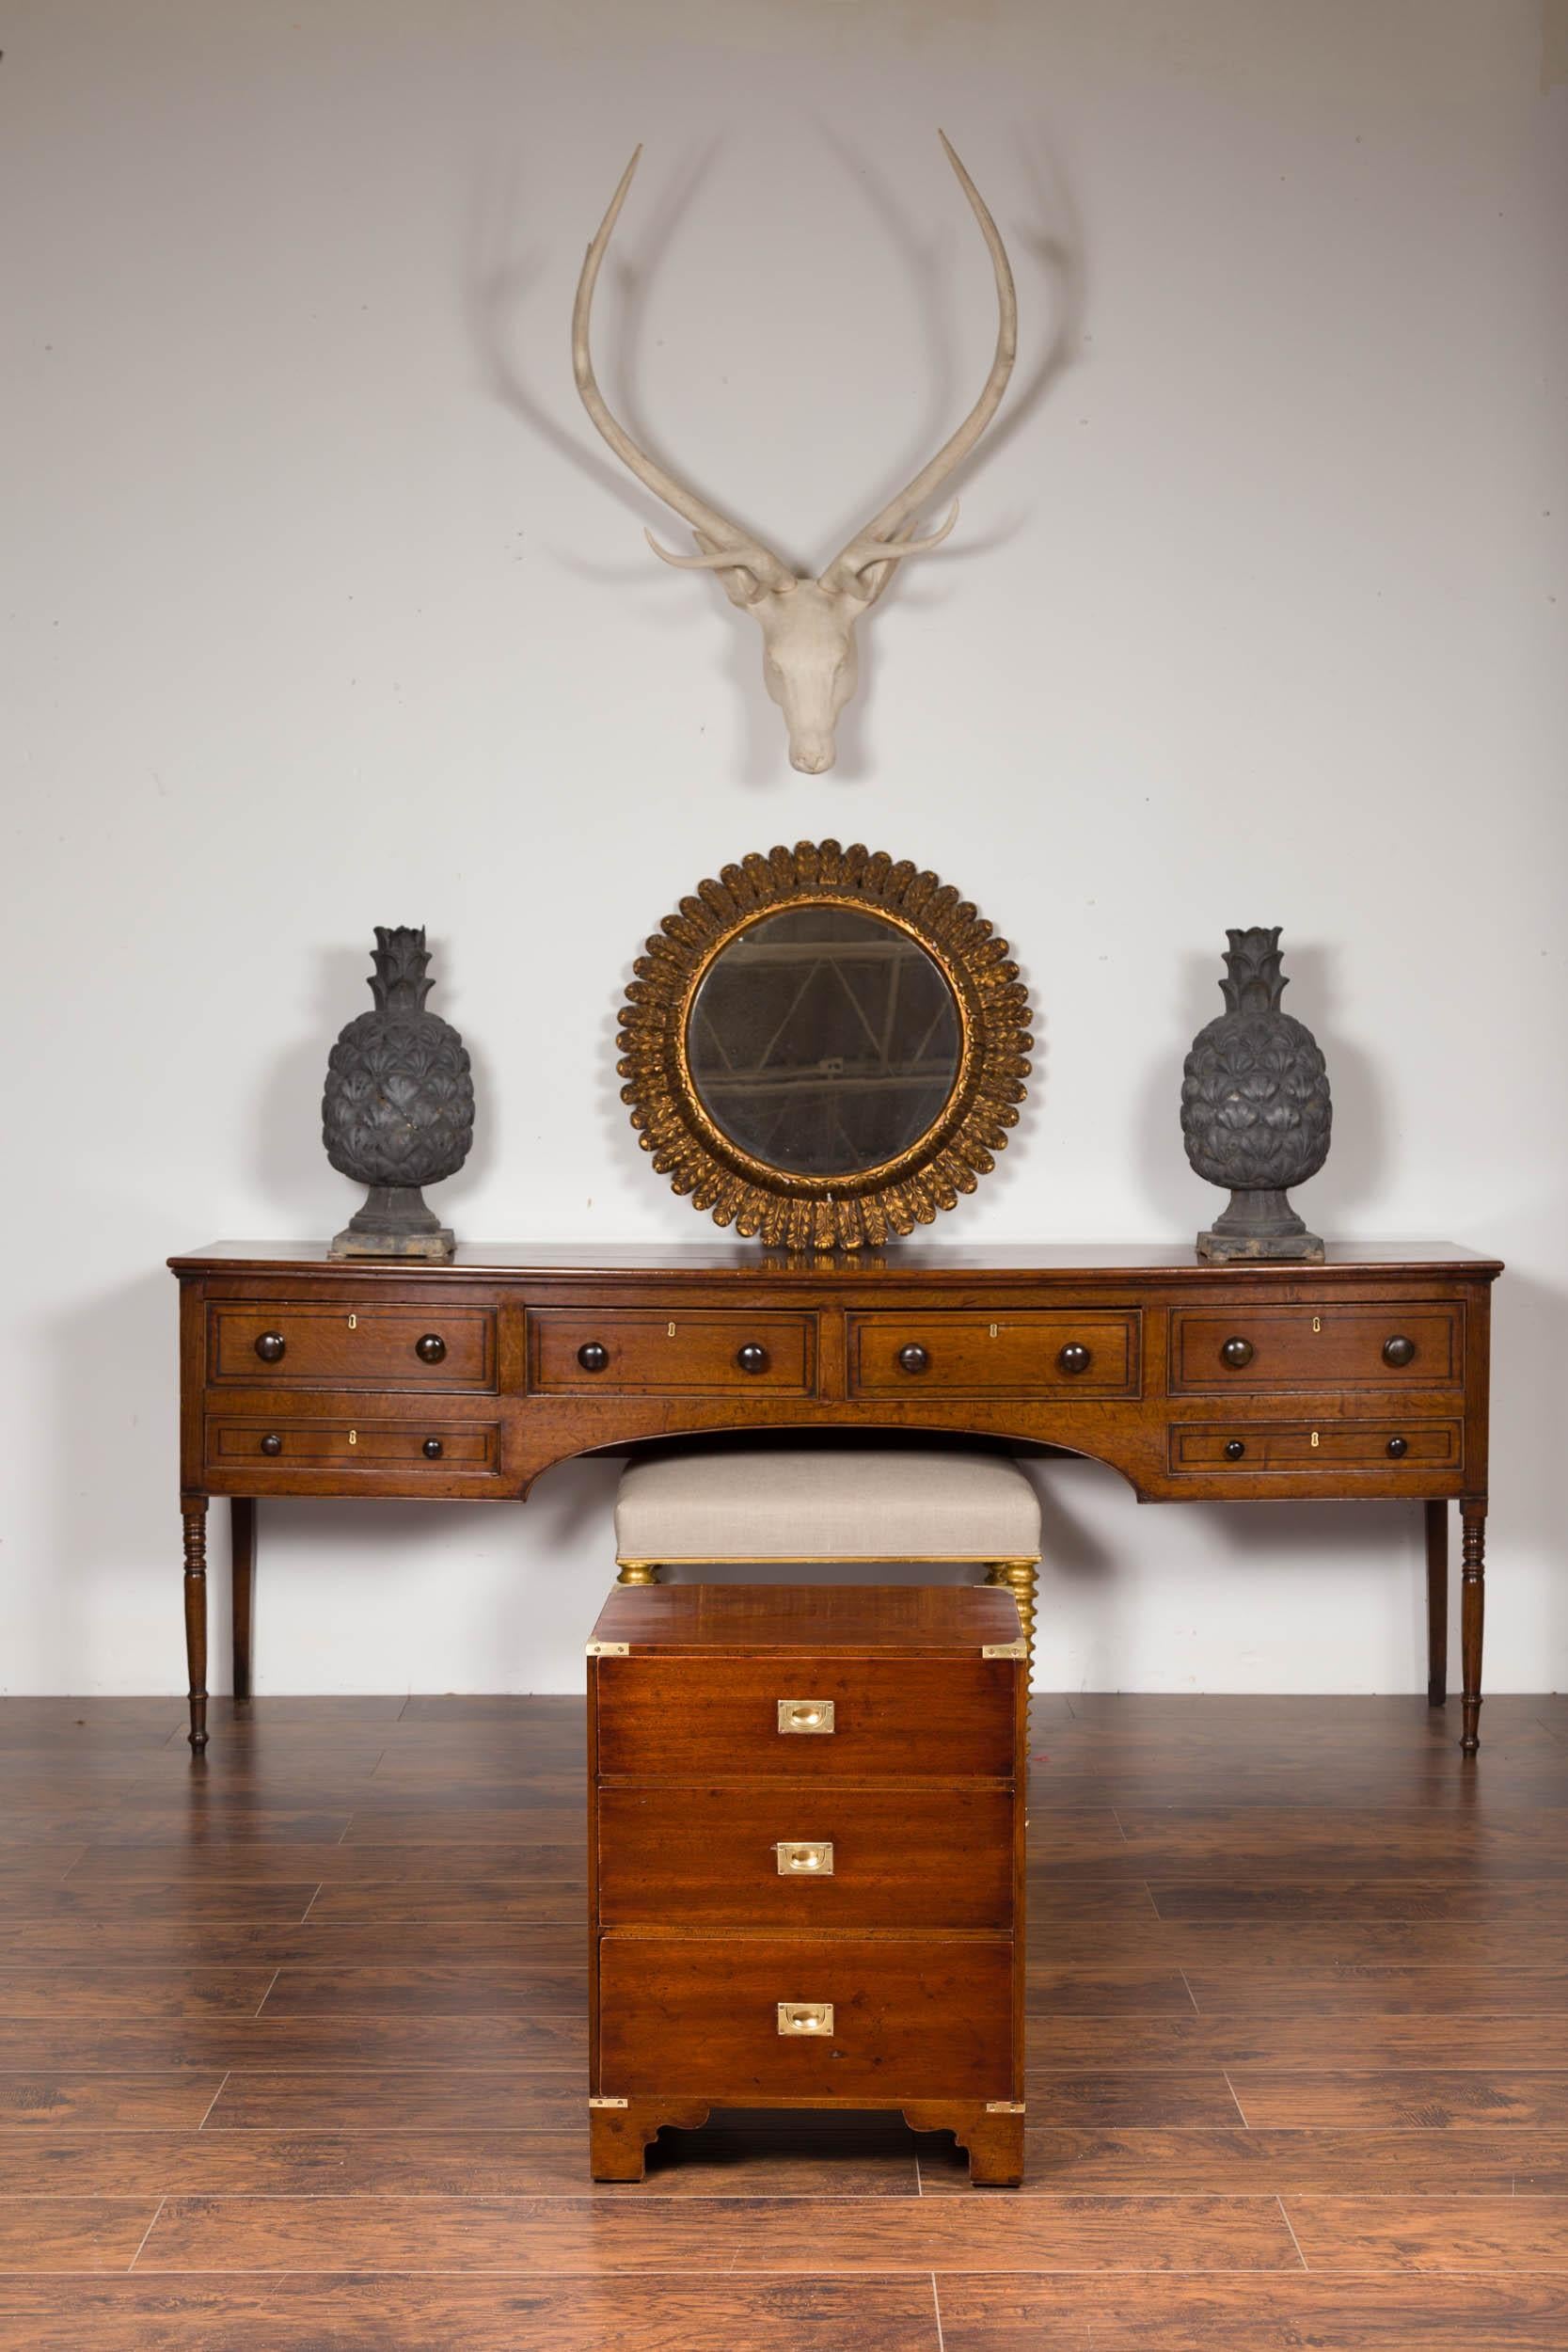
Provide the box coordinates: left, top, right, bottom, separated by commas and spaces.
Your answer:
588, 1585, 1027, 2183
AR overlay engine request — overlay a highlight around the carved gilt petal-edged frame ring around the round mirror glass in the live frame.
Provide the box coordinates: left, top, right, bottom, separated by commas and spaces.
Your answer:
616, 842, 1035, 1249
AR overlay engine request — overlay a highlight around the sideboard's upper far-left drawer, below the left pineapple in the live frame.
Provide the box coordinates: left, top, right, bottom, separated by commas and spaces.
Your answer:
207, 1301, 496, 1391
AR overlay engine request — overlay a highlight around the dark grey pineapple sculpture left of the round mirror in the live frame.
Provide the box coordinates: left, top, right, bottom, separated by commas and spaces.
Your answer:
322, 925, 472, 1259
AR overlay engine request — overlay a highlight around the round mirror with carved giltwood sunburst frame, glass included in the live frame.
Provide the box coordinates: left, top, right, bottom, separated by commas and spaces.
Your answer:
616, 842, 1035, 1249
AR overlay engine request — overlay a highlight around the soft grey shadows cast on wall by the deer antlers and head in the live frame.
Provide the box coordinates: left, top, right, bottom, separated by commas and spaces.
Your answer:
463, 132, 1086, 788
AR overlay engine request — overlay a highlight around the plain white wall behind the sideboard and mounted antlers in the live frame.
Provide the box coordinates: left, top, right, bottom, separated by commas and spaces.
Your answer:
0, 0, 1568, 1692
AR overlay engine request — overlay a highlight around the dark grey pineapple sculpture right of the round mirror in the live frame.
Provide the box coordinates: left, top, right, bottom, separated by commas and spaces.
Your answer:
1182, 925, 1333, 1261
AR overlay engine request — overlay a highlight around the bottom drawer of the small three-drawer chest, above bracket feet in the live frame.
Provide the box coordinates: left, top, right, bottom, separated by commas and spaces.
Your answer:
599, 1933, 1013, 2106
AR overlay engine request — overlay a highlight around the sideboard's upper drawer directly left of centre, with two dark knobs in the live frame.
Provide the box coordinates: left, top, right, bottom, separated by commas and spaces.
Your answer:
529, 1308, 816, 1397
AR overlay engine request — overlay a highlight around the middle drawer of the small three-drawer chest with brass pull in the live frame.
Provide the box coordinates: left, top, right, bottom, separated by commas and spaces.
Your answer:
599, 1783, 1013, 1933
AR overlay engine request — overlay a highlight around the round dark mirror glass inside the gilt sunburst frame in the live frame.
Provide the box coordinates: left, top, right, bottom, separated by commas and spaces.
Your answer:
687, 906, 961, 1176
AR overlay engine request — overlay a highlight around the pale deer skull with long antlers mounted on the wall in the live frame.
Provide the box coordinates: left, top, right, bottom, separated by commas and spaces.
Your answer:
571, 132, 1018, 776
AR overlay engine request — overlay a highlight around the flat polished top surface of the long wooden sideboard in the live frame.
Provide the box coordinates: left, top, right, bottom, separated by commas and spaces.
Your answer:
169, 1242, 1502, 1282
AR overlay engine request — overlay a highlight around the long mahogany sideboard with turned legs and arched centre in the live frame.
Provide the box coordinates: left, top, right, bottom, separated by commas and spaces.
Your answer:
169, 1242, 1502, 1755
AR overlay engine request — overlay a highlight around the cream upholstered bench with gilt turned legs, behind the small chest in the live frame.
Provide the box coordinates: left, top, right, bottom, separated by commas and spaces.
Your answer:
616, 1447, 1039, 1663
